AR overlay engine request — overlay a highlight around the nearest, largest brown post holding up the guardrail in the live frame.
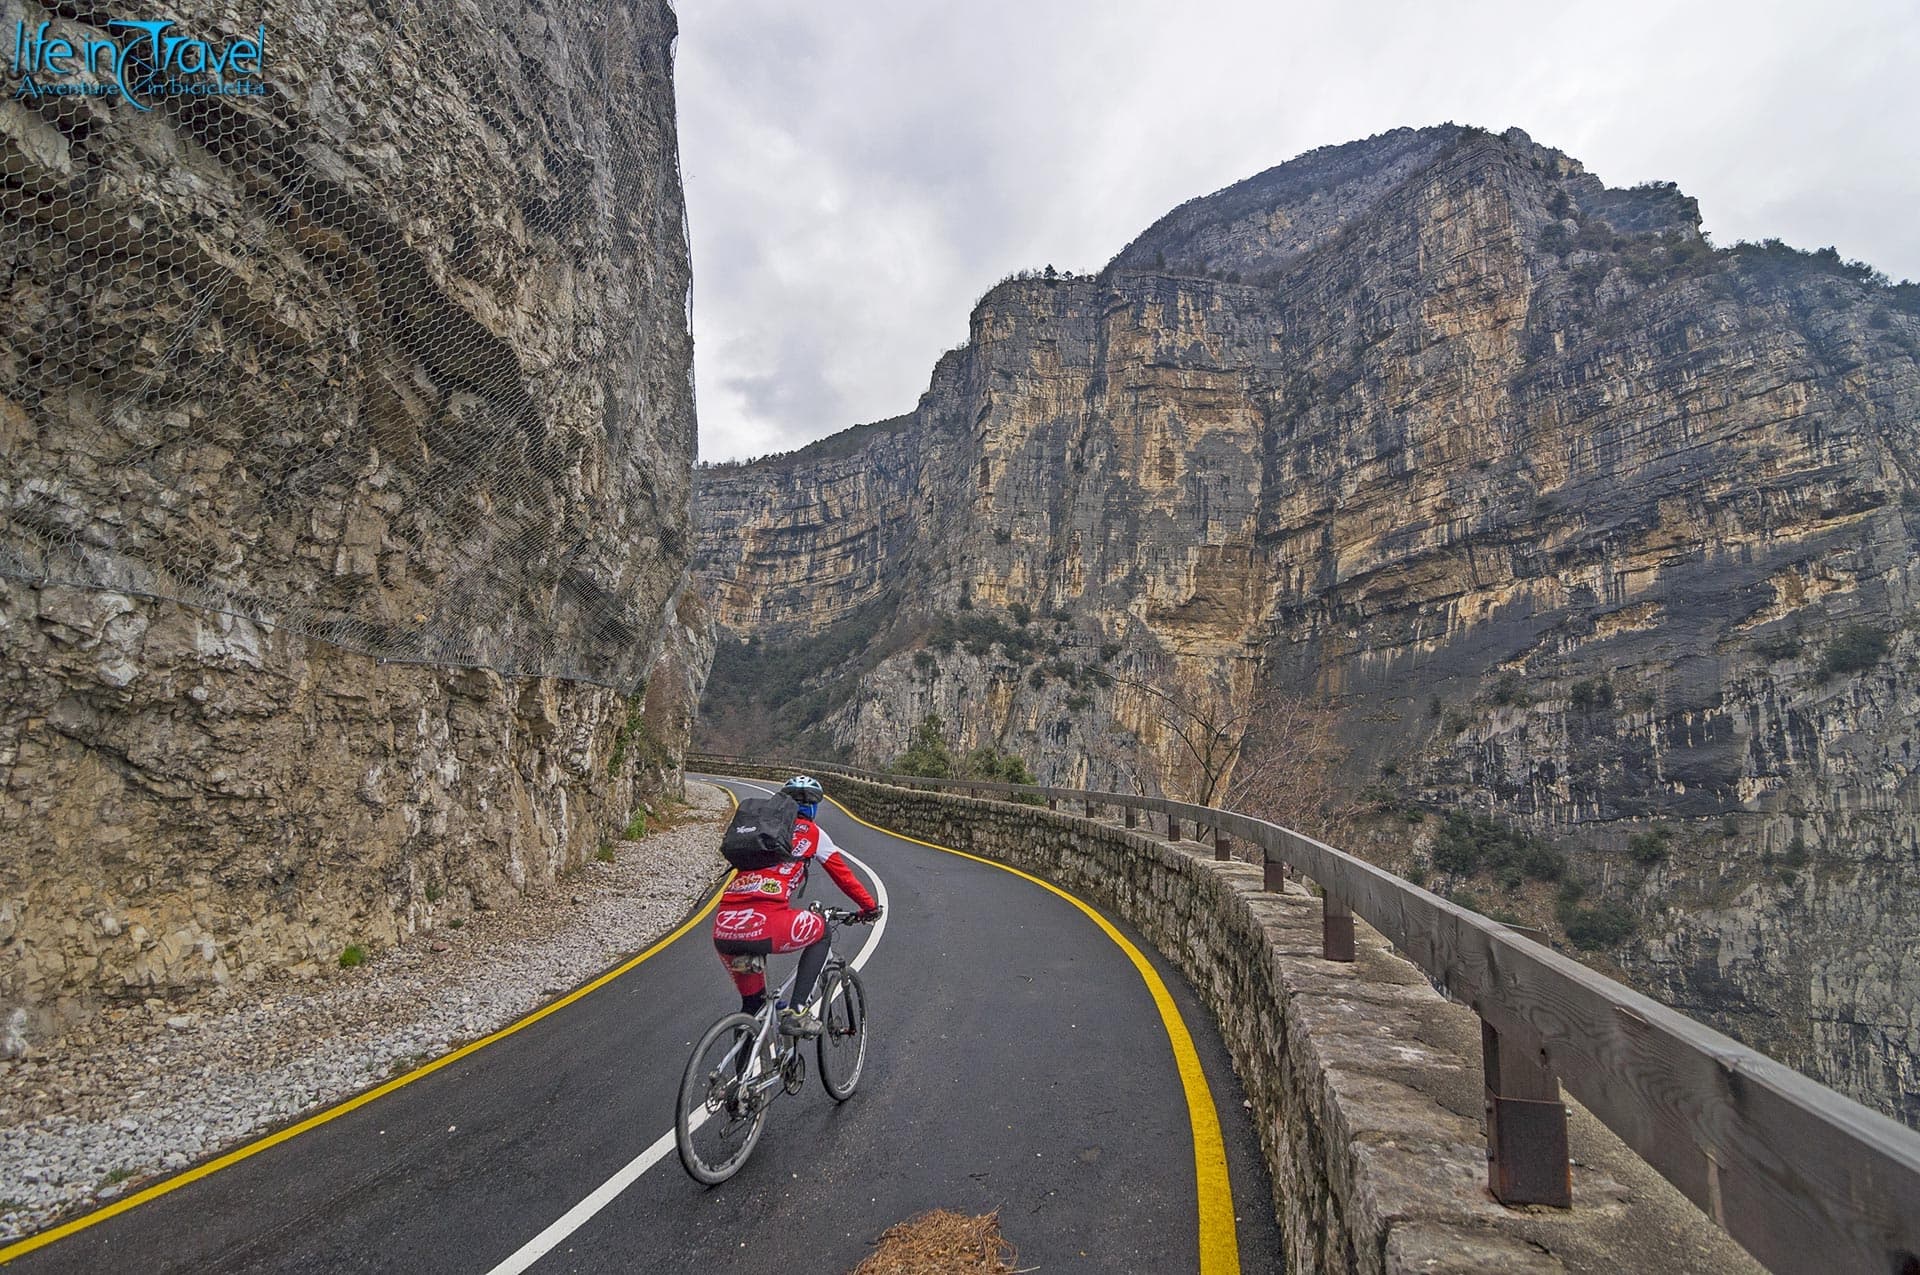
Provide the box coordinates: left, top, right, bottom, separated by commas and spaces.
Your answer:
1480, 1018, 1572, 1208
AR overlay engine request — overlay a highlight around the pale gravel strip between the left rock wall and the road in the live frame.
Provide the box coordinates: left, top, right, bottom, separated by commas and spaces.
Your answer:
0, 783, 730, 1242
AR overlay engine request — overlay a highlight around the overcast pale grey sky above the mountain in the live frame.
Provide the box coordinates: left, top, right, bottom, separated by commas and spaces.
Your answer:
678, 0, 1920, 461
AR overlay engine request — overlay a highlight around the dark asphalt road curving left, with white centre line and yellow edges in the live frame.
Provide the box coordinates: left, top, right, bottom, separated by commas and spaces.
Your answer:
6, 785, 1281, 1275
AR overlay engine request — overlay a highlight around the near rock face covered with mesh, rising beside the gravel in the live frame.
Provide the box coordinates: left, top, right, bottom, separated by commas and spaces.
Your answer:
0, 0, 710, 1031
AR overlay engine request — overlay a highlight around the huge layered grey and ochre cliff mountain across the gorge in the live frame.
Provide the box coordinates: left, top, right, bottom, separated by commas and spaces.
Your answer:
697, 127, 1920, 1121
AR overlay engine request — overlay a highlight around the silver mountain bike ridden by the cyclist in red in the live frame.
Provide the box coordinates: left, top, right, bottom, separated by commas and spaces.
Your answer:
674, 902, 866, 1187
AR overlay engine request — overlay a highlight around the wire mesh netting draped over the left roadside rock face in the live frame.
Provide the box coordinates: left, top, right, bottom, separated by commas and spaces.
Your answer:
0, 0, 693, 687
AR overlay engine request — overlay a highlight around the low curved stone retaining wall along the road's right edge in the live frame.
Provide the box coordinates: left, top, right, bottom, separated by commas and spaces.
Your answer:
728, 766, 1759, 1275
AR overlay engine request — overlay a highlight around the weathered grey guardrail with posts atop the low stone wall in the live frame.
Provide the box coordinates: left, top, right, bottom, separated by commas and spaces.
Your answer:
687, 753, 1920, 1275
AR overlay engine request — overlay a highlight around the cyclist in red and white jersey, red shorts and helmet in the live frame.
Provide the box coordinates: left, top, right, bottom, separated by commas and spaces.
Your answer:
714, 774, 881, 1037
